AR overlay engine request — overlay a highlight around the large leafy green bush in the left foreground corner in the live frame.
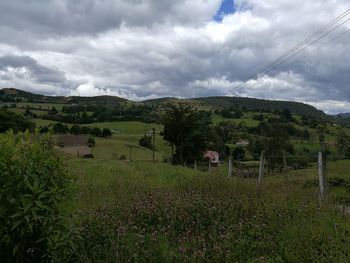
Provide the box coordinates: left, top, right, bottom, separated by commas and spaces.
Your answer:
0, 133, 70, 262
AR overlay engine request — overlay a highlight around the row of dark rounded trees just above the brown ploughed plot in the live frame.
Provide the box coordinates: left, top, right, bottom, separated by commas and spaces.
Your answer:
40, 122, 112, 137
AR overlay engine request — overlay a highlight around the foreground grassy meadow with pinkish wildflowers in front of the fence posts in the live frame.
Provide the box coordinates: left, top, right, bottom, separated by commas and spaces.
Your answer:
67, 158, 350, 262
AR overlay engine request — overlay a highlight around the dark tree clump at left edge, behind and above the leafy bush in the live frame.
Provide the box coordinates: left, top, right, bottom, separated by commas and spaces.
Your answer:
0, 108, 35, 132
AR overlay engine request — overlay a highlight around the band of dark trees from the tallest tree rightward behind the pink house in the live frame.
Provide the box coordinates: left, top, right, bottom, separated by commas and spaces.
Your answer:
163, 104, 302, 164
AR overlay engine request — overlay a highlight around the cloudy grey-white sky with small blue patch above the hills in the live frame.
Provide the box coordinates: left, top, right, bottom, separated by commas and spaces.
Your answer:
0, 0, 350, 114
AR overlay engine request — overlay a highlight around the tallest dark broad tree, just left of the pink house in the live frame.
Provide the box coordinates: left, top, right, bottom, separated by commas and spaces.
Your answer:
163, 104, 210, 164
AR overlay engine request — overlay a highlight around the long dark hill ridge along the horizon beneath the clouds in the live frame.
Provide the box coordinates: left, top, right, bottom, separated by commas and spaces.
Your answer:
0, 88, 330, 119
